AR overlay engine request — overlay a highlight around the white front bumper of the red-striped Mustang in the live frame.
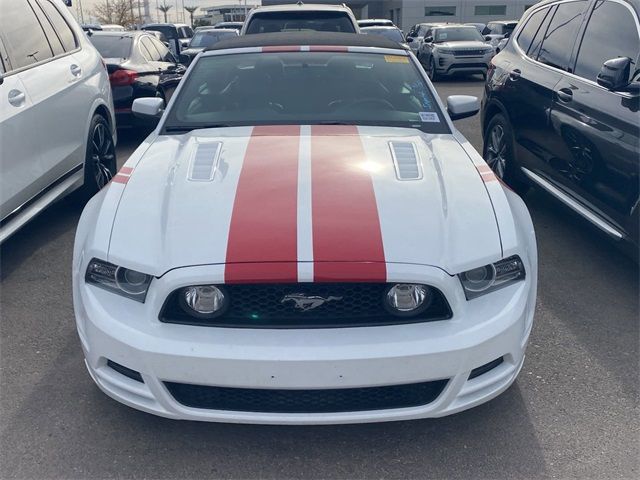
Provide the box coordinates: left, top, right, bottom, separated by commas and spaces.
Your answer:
74, 265, 535, 424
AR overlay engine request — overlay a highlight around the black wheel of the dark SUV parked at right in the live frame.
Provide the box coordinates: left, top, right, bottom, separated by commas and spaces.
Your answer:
482, 113, 529, 195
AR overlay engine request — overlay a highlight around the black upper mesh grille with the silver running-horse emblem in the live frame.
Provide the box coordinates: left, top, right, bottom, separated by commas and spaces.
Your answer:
160, 283, 451, 328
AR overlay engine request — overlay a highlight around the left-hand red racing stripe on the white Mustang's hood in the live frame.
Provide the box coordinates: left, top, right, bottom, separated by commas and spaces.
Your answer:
225, 125, 300, 283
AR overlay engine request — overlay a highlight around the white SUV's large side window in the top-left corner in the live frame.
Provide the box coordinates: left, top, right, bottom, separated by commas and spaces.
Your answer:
0, 0, 53, 69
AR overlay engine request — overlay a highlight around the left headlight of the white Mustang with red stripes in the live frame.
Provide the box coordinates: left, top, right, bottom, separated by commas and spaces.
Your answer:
85, 258, 152, 303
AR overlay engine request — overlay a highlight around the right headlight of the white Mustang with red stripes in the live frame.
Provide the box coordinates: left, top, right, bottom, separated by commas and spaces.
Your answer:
458, 255, 525, 300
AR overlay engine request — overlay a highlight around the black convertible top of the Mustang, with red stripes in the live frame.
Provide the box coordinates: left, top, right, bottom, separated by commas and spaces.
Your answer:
205, 32, 403, 52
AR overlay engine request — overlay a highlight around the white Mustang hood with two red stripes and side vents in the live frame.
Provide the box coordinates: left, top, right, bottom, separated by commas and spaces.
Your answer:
108, 126, 501, 275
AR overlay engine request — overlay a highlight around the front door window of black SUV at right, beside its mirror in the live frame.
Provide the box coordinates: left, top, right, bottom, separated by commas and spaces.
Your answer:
575, 1, 640, 81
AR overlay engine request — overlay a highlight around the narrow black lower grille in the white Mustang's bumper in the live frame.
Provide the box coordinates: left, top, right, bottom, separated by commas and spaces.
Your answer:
165, 380, 447, 413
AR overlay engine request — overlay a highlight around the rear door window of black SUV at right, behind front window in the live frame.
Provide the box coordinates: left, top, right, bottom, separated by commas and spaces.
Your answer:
538, 1, 586, 70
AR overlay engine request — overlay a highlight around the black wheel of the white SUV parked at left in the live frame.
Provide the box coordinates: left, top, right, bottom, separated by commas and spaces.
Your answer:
81, 114, 117, 200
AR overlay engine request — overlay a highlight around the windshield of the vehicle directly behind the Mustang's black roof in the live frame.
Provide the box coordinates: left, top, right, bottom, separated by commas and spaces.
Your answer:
246, 11, 356, 34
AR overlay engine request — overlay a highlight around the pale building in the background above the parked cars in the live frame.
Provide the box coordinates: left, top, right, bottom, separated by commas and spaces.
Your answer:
262, 0, 539, 32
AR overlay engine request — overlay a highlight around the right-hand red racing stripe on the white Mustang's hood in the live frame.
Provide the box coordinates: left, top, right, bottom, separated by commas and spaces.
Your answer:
311, 125, 387, 282
